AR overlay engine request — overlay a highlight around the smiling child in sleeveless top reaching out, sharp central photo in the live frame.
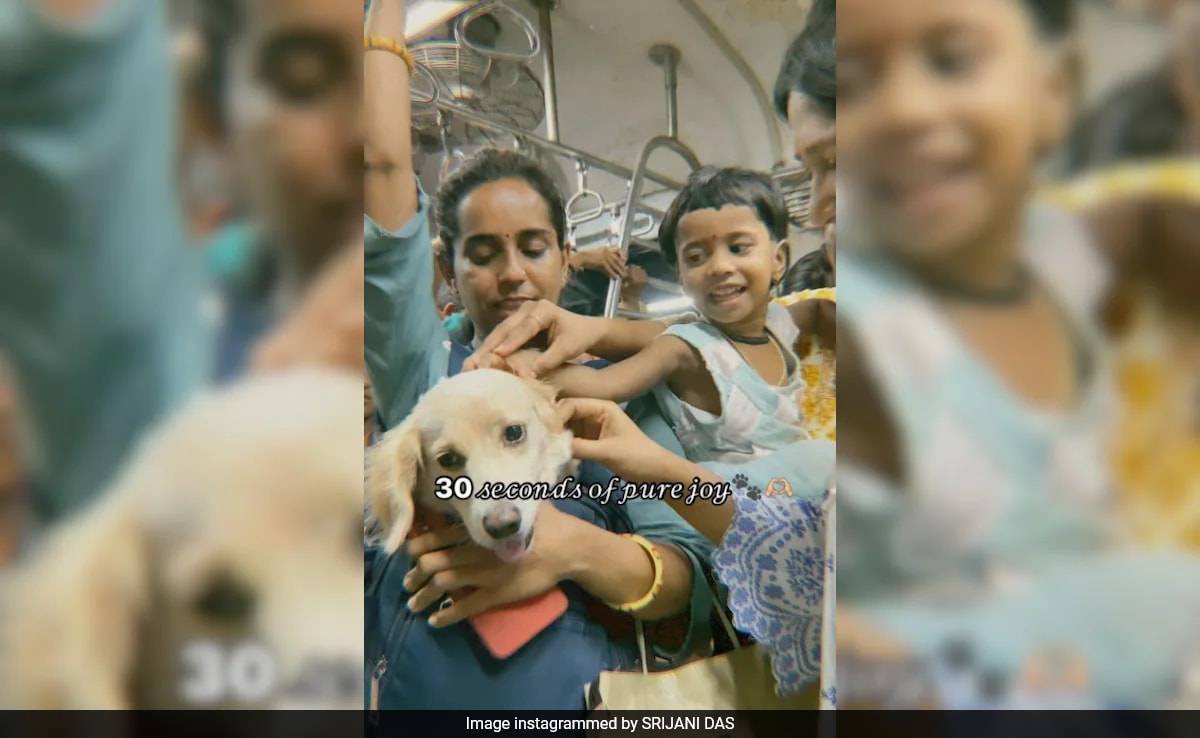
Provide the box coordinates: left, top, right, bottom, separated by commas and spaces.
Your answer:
537, 168, 804, 463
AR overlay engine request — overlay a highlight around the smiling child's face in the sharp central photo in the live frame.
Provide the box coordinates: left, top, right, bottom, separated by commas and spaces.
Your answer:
678, 205, 786, 325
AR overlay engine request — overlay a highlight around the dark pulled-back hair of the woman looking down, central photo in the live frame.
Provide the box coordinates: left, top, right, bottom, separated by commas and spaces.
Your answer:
433, 149, 566, 264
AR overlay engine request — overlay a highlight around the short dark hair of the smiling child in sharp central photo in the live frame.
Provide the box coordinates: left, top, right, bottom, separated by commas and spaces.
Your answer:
659, 167, 787, 265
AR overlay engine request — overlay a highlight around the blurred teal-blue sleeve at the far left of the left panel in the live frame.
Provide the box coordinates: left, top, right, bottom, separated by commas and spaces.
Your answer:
0, 0, 210, 521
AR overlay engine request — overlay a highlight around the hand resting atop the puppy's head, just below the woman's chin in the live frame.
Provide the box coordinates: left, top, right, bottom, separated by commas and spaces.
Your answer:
462, 300, 604, 379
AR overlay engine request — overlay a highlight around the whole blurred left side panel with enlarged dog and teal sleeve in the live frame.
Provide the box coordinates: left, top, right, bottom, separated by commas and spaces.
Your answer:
0, 0, 362, 709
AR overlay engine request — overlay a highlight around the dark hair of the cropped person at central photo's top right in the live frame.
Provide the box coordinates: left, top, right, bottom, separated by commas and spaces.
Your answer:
774, 0, 838, 119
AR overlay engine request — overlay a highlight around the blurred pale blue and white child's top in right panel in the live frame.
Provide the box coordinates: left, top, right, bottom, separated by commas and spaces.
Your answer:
838, 204, 1200, 708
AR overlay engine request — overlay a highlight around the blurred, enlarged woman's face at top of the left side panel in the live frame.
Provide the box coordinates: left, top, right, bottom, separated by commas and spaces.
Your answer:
228, 0, 364, 266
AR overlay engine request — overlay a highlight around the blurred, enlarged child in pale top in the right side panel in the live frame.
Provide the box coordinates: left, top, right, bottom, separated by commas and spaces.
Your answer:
838, 0, 1200, 706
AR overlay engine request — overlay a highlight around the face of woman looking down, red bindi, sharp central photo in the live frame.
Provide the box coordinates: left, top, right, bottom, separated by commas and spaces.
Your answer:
445, 179, 568, 337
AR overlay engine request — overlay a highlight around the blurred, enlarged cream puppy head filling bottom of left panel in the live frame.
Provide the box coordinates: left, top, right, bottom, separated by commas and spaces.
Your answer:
0, 370, 364, 710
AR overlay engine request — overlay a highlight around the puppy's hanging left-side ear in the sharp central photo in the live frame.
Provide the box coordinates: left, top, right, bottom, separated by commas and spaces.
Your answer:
366, 420, 424, 554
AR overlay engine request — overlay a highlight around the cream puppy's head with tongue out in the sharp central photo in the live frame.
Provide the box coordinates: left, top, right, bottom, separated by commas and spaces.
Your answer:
367, 370, 576, 562
